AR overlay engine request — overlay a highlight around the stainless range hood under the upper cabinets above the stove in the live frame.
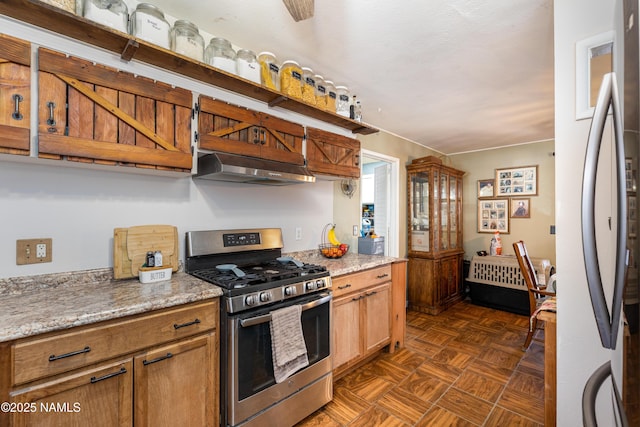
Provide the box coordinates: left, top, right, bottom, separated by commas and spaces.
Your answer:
195, 152, 316, 185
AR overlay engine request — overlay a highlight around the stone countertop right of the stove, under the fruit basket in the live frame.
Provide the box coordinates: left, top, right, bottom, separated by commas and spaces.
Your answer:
285, 250, 405, 277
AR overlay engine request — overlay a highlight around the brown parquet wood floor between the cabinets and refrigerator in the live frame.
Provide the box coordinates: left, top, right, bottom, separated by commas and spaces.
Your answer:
297, 301, 544, 427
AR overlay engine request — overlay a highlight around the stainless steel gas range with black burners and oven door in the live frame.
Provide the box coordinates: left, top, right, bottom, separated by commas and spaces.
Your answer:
185, 228, 333, 427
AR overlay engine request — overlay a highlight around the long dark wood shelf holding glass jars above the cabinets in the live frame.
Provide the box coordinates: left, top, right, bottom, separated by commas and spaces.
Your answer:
0, 0, 378, 135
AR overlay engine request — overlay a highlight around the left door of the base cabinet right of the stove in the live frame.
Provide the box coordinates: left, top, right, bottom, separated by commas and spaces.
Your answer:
332, 293, 363, 370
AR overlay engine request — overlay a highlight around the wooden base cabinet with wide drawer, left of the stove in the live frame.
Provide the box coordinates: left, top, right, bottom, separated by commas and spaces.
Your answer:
0, 300, 219, 426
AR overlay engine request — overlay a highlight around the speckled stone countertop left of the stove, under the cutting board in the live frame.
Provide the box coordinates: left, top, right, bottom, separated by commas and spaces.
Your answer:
0, 269, 222, 342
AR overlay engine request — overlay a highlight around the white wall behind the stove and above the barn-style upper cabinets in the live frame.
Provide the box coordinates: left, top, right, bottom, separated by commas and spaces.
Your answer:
0, 17, 344, 278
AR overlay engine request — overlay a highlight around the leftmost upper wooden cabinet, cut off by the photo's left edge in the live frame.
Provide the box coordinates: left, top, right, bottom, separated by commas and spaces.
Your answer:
0, 34, 31, 156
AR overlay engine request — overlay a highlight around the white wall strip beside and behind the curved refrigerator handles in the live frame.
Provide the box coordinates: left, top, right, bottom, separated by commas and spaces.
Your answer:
554, 0, 621, 426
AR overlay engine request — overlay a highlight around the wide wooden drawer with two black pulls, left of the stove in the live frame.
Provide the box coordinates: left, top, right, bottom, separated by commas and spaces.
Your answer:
12, 300, 218, 384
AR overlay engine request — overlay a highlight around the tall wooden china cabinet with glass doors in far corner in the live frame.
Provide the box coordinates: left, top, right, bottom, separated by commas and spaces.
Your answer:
407, 156, 464, 314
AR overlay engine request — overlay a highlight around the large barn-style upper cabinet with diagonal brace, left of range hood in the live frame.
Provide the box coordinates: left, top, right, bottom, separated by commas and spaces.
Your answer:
38, 48, 193, 171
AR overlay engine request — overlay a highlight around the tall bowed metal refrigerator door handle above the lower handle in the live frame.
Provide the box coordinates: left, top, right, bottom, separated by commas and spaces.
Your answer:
581, 73, 627, 349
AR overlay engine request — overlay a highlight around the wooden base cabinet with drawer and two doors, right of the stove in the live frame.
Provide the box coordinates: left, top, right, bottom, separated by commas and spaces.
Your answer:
332, 265, 392, 378
